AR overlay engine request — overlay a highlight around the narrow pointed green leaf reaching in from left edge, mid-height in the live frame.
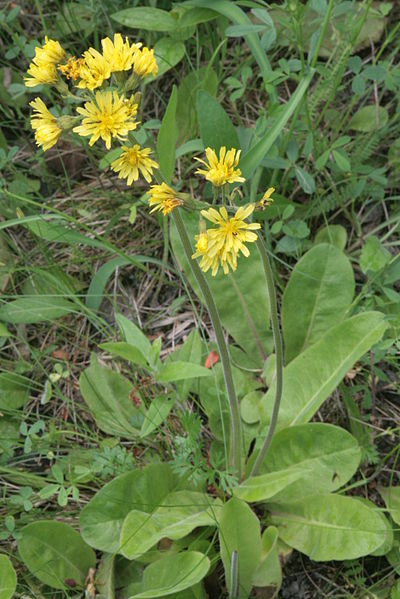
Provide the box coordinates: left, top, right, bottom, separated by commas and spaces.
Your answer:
0, 295, 77, 324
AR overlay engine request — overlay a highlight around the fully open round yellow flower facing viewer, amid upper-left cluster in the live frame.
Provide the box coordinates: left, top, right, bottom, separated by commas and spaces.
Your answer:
73, 91, 138, 150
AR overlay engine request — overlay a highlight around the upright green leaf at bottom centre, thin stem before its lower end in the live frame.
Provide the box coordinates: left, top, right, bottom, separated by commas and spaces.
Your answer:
219, 497, 261, 599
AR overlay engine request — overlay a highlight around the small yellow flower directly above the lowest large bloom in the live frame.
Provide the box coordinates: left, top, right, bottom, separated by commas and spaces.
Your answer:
195, 146, 245, 187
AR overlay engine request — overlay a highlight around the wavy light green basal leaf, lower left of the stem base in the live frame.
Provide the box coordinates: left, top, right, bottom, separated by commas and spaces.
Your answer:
121, 491, 219, 559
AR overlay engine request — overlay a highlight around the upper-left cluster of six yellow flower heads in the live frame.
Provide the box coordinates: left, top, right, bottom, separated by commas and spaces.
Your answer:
25, 33, 158, 185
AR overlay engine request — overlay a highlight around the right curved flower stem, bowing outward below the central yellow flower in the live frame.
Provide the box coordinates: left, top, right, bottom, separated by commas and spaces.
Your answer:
250, 234, 283, 476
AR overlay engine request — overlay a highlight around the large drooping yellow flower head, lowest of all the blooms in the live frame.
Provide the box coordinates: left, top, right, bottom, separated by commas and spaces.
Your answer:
192, 204, 261, 276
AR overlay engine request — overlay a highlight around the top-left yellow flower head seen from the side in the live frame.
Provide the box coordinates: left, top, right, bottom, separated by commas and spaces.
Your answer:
25, 36, 65, 87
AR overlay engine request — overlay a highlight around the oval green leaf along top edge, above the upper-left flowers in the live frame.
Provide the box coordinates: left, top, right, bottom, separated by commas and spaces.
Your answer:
111, 6, 177, 31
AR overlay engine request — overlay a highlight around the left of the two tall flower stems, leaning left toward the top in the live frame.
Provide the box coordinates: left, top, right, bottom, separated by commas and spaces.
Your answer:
172, 210, 242, 480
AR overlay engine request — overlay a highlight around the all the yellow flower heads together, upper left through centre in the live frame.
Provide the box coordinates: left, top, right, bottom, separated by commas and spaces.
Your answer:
25, 38, 275, 276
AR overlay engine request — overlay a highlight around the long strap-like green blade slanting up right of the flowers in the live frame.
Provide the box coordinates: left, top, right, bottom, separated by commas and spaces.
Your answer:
240, 70, 314, 179
